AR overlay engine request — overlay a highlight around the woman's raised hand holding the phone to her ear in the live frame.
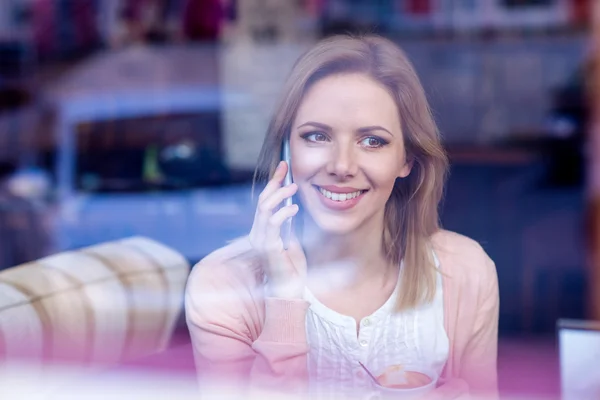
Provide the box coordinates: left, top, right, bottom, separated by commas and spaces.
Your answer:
250, 161, 306, 299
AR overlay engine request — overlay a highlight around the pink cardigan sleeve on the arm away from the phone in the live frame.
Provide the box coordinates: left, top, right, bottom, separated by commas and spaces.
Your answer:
458, 255, 500, 398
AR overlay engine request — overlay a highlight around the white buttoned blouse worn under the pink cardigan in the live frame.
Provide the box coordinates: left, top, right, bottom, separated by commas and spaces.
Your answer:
304, 254, 449, 398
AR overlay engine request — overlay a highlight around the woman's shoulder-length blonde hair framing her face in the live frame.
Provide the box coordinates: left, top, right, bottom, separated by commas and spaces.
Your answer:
254, 35, 448, 311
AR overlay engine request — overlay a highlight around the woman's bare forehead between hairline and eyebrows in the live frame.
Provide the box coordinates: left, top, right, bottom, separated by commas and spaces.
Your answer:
296, 74, 400, 129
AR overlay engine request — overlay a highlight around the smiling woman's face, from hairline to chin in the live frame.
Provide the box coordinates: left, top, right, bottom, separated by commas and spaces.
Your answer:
290, 74, 411, 234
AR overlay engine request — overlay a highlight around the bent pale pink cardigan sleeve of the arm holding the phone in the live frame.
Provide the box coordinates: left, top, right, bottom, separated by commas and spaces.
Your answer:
185, 265, 308, 394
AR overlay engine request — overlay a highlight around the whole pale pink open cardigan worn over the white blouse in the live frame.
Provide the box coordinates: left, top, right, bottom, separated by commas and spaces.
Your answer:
185, 231, 499, 398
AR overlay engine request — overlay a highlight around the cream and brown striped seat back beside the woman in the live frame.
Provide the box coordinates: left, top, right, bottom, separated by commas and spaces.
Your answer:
0, 237, 190, 366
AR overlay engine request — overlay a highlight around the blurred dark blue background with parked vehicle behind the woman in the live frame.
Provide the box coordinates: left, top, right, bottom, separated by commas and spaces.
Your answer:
0, 0, 600, 396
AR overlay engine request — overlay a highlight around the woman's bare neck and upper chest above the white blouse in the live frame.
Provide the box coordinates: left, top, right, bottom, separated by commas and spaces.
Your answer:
301, 212, 398, 286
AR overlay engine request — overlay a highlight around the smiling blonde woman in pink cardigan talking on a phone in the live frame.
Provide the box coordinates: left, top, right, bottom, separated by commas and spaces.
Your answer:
186, 36, 499, 398
